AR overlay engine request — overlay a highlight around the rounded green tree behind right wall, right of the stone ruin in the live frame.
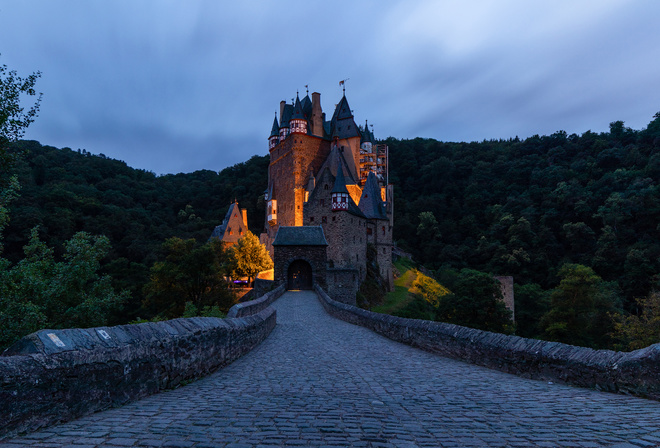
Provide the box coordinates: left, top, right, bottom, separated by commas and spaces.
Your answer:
541, 264, 620, 348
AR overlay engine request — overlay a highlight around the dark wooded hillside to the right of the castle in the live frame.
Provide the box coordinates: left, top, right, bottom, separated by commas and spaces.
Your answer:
386, 113, 660, 342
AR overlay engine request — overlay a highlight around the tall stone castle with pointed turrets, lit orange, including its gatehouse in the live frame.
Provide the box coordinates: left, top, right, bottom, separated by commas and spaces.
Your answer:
260, 89, 393, 302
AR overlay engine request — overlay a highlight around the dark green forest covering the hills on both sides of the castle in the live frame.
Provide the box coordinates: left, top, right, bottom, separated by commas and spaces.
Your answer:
2, 114, 660, 348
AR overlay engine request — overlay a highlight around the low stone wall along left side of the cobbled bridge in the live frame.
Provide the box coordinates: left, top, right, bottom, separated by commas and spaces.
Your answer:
0, 306, 276, 439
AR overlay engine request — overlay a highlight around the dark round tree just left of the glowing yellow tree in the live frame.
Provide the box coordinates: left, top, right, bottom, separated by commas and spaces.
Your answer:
144, 237, 234, 319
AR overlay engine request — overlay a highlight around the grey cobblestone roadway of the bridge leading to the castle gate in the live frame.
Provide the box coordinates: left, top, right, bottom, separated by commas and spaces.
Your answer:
0, 292, 660, 448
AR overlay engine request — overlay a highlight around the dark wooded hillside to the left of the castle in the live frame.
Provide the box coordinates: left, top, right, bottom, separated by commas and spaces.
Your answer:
3, 141, 268, 323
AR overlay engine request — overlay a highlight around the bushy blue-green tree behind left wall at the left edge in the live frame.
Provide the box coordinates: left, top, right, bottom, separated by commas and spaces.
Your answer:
0, 228, 129, 346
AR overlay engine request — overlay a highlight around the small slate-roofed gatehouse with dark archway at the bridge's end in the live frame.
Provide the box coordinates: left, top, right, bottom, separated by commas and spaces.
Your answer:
273, 226, 328, 289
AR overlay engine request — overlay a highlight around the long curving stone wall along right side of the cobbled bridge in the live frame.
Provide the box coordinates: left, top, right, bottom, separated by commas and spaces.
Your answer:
316, 286, 660, 400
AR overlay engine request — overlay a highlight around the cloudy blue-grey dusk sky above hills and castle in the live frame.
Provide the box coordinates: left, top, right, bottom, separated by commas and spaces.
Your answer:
0, 0, 660, 174
